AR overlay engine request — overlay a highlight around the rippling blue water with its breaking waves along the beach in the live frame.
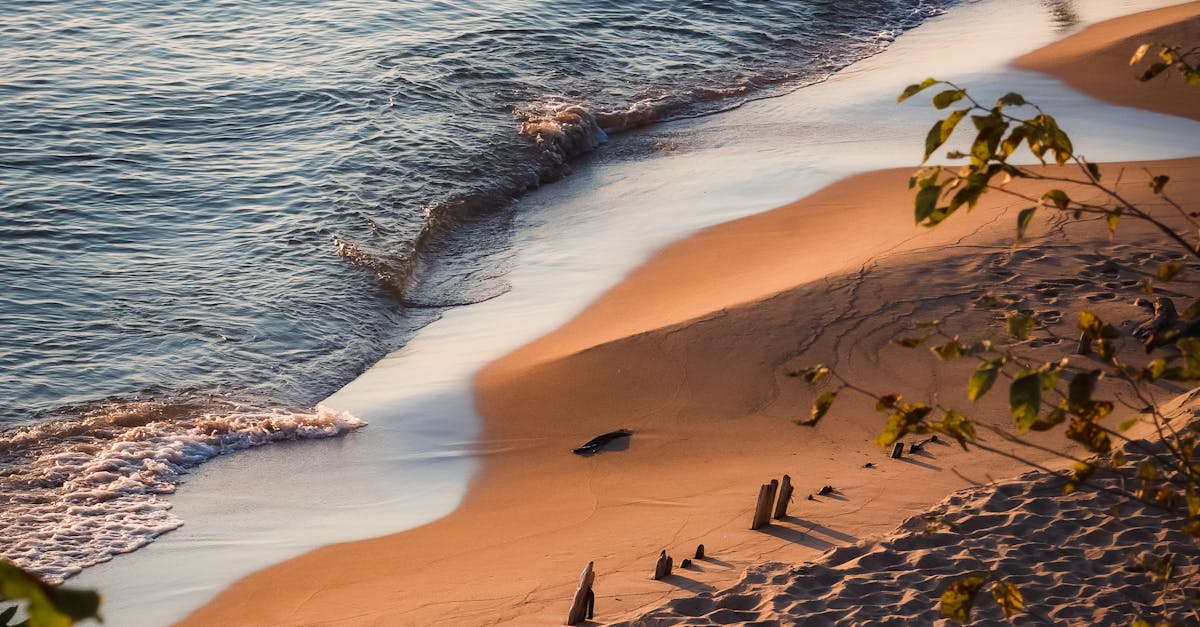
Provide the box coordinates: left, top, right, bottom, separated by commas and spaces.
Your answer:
0, 0, 949, 580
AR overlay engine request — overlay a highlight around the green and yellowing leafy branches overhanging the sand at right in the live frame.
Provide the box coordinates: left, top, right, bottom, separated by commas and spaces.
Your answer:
792, 43, 1200, 625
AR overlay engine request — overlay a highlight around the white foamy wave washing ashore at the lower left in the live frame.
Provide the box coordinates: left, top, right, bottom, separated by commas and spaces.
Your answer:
0, 402, 366, 584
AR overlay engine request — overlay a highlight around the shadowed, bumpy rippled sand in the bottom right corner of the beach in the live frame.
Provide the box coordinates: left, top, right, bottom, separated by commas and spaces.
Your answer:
618, 410, 1200, 627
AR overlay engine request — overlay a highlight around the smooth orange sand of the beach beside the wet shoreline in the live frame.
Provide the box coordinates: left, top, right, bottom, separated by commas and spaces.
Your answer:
182, 2, 1200, 625
